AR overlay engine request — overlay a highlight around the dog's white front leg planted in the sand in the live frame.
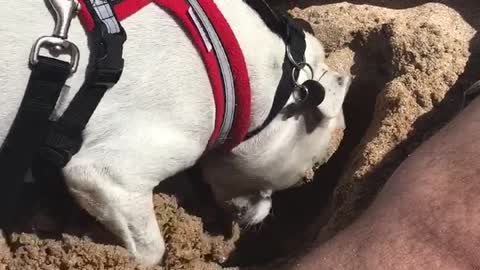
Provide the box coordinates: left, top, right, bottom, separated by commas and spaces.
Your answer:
64, 160, 165, 265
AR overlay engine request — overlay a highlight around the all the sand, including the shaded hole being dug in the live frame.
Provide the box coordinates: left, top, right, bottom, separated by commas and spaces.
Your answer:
0, 0, 480, 270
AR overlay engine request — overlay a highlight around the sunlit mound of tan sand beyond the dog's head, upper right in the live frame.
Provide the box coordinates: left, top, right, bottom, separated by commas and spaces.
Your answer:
294, 1, 480, 236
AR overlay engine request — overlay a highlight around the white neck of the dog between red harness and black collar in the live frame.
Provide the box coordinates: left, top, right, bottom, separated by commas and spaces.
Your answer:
215, 0, 285, 131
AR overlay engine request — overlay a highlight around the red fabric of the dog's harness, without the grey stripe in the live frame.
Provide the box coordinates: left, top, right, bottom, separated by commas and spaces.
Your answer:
79, 0, 251, 151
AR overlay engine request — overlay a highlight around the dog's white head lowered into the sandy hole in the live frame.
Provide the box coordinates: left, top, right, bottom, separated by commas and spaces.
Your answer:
202, 22, 351, 225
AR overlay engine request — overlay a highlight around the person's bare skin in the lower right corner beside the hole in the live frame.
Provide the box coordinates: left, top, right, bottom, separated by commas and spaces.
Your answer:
271, 97, 480, 270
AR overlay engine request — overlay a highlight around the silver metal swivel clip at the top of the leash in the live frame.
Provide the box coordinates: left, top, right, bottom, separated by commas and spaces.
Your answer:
30, 0, 80, 74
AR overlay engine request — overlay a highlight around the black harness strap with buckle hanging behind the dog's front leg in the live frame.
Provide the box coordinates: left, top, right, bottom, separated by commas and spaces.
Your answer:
36, 0, 127, 169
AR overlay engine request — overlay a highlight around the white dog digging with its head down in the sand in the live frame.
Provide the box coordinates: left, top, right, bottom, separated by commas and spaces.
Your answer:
0, 0, 350, 264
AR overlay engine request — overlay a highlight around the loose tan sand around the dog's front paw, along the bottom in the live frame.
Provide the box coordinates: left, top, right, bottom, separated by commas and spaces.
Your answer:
0, 193, 239, 270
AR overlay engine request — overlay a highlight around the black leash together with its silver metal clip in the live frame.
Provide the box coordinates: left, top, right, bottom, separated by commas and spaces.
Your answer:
0, 0, 79, 231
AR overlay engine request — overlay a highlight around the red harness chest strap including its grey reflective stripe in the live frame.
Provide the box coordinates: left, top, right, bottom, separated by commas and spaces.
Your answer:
79, 0, 251, 151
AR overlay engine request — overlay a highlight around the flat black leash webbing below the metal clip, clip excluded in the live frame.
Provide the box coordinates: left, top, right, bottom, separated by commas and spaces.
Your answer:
0, 56, 71, 229
